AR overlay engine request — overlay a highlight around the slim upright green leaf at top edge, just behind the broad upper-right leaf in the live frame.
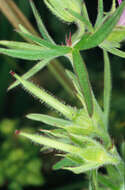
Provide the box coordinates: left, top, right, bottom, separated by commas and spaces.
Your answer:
94, 0, 103, 28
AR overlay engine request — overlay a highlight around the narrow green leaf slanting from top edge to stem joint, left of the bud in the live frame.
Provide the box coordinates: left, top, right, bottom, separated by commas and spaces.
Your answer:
30, 0, 54, 43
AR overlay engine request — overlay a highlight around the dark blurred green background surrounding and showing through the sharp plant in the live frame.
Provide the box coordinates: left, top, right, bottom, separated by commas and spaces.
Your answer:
0, 0, 125, 190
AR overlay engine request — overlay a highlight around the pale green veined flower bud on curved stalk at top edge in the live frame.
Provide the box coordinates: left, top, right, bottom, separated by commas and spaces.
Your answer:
44, 0, 82, 23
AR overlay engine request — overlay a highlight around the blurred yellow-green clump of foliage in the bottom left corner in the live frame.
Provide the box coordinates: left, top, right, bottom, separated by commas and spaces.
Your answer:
0, 119, 44, 190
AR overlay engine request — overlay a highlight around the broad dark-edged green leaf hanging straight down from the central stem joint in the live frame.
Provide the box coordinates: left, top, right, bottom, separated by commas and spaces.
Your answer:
72, 50, 93, 116
